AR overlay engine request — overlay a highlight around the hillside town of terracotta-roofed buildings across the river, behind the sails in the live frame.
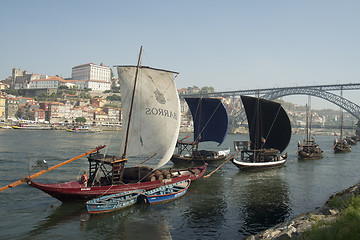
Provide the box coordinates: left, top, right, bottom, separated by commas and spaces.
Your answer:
0, 63, 357, 134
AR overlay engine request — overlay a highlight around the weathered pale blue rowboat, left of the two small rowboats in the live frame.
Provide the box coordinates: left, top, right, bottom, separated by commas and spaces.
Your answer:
86, 189, 145, 214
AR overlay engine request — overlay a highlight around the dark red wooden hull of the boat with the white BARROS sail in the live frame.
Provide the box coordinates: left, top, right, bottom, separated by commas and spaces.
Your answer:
29, 164, 207, 202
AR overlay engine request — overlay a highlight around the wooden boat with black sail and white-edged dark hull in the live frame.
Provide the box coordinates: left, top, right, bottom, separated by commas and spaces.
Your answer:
232, 96, 291, 170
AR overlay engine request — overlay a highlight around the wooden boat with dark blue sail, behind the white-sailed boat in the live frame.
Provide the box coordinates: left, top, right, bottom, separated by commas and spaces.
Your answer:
171, 98, 230, 164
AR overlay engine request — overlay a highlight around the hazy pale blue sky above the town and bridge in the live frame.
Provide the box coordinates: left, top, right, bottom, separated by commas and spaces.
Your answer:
0, 0, 360, 107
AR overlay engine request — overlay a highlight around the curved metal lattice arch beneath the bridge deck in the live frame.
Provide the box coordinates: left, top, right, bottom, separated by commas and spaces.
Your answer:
262, 88, 360, 120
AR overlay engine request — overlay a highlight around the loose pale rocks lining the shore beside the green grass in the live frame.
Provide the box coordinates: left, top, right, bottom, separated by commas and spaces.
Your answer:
245, 183, 360, 240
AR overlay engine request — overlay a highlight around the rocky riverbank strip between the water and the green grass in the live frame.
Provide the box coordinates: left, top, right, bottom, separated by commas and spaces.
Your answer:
245, 183, 360, 240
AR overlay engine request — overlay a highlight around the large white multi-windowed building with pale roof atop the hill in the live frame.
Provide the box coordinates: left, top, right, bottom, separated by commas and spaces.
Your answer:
71, 63, 111, 83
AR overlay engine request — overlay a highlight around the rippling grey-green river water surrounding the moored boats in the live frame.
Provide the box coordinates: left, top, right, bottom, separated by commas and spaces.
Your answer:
0, 129, 360, 239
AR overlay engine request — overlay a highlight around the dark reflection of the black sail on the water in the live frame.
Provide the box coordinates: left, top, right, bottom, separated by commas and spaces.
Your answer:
234, 169, 291, 235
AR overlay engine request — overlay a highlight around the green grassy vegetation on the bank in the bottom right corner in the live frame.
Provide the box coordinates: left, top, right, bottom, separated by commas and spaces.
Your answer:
297, 194, 360, 240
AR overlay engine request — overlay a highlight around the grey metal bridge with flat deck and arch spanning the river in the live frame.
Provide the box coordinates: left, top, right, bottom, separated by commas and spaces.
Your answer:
180, 83, 360, 120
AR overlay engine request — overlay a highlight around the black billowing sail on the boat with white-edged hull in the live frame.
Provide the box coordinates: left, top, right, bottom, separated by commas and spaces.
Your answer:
241, 96, 291, 152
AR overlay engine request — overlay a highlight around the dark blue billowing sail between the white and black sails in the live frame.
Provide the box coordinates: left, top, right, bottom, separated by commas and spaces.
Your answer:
185, 98, 229, 145
